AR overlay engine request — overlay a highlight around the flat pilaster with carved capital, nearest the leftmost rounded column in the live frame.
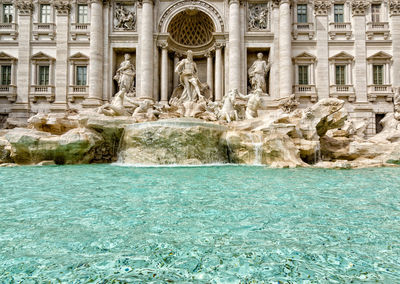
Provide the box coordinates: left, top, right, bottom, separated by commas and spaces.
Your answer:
51, 1, 70, 111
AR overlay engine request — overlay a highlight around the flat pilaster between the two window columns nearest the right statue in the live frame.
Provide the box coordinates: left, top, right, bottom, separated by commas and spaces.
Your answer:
314, 1, 332, 99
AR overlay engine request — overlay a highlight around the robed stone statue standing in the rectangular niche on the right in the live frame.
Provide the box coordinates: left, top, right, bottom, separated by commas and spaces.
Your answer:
248, 52, 271, 93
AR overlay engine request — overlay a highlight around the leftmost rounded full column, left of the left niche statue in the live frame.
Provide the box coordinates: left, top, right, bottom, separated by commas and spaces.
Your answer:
83, 0, 104, 107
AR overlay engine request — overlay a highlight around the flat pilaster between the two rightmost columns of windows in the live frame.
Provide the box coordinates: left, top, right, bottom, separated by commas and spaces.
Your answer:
351, 1, 369, 102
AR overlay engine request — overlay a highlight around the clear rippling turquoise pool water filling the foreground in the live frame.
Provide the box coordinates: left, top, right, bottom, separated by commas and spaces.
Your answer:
0, 165, 400, 283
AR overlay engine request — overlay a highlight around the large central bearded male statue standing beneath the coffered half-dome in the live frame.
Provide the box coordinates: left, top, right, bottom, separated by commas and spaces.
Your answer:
175, 50, 203, 103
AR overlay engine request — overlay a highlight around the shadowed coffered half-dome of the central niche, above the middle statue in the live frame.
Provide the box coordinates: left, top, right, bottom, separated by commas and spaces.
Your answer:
168, 11, 215, 47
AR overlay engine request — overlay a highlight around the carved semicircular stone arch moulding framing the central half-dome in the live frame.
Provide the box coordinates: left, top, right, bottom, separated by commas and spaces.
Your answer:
158, 0, 224, 33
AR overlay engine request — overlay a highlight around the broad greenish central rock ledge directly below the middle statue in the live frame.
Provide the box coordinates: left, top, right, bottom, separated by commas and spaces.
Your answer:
119, 119, 228, 165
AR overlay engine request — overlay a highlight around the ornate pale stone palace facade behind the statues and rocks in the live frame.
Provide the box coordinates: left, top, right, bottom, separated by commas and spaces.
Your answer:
0, 0, 400, 135
